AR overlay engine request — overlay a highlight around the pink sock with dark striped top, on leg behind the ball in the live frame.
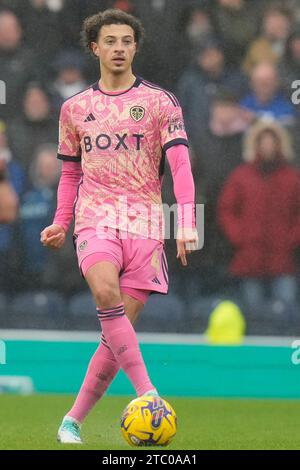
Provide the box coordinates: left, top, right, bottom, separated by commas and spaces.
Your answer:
97, 303, 155, 396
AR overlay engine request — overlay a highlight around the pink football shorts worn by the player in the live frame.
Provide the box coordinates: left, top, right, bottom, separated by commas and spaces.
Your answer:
74, 227, 169, 303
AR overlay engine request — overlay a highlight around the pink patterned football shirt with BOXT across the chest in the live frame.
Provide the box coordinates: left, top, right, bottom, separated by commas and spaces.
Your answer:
58, 78, 188, 240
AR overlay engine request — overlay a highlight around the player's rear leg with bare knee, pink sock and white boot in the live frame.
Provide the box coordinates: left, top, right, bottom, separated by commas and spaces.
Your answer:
58, 293, 146, 443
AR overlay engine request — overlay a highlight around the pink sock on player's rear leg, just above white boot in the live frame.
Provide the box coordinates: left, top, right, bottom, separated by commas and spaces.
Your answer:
67, 336, 120, 423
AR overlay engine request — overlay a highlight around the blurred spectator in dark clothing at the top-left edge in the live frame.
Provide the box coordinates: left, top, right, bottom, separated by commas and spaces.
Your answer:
0, 10, 36, 119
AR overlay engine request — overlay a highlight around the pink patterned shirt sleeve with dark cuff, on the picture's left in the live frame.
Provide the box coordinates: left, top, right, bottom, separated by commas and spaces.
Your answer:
57, 102, 81, 162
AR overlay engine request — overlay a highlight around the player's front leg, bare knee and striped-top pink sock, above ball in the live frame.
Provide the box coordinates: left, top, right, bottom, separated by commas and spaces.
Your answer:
85, 261, 154, 396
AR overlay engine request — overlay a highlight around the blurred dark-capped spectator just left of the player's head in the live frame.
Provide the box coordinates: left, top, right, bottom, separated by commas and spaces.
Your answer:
50, 50, 88, 113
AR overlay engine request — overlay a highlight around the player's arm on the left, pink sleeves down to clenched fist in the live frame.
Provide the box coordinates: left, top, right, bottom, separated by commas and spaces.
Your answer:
41, 101, 82, 249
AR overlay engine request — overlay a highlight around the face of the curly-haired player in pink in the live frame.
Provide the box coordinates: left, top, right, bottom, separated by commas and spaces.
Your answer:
92, 24, 137, 74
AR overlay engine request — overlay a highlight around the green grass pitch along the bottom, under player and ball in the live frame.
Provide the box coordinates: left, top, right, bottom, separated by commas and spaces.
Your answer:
0, 395, 300, 450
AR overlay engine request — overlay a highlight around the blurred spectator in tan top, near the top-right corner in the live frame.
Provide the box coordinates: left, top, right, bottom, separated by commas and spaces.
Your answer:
244, 6, 293, 74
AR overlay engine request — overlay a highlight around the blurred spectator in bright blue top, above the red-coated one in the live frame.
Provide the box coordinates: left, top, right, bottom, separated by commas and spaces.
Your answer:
240, 62, 296, 126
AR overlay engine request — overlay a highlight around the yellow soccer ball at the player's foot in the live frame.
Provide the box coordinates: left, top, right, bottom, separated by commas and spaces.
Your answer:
121, 396, 177, 446
